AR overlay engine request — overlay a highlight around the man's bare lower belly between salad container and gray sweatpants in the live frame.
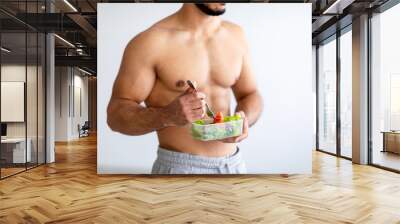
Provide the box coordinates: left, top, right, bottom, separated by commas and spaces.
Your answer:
157, 125, 236, 157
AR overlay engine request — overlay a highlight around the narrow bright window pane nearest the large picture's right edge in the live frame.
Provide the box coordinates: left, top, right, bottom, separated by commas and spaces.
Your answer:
318, 37, 336, 153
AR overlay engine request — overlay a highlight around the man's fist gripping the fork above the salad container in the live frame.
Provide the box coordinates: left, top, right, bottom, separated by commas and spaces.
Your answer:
164, 88, 206, 126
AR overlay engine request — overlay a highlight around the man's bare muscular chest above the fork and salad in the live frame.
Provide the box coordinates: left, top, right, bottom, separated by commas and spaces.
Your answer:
156, 37, 243, 91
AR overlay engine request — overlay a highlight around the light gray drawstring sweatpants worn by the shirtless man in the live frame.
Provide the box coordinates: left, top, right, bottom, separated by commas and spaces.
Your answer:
151, 147, 246, 174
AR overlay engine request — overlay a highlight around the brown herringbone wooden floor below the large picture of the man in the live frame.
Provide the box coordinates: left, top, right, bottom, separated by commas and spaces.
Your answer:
0, 134, 400, 224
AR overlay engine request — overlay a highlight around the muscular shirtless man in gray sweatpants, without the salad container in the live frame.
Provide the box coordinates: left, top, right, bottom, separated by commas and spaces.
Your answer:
107, 3, 262, 174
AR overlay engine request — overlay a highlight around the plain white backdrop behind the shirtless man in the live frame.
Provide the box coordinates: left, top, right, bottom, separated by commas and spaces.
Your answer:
97, 3, 314, 174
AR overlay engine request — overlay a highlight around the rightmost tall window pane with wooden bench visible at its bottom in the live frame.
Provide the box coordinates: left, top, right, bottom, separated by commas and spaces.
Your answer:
371, 4, 400, 170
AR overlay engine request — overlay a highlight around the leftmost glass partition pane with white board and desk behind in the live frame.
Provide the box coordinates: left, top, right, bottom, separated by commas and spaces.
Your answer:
0, 32, 30, 178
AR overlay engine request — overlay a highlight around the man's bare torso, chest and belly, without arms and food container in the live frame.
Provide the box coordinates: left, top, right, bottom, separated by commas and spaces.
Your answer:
145, 17, 243, 156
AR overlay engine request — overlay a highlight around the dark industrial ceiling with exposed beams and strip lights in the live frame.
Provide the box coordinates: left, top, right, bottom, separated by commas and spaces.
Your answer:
0, 0, 394, 74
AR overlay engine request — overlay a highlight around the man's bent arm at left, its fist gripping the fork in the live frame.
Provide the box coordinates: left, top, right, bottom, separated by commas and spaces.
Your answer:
107, 30, 204, 135
